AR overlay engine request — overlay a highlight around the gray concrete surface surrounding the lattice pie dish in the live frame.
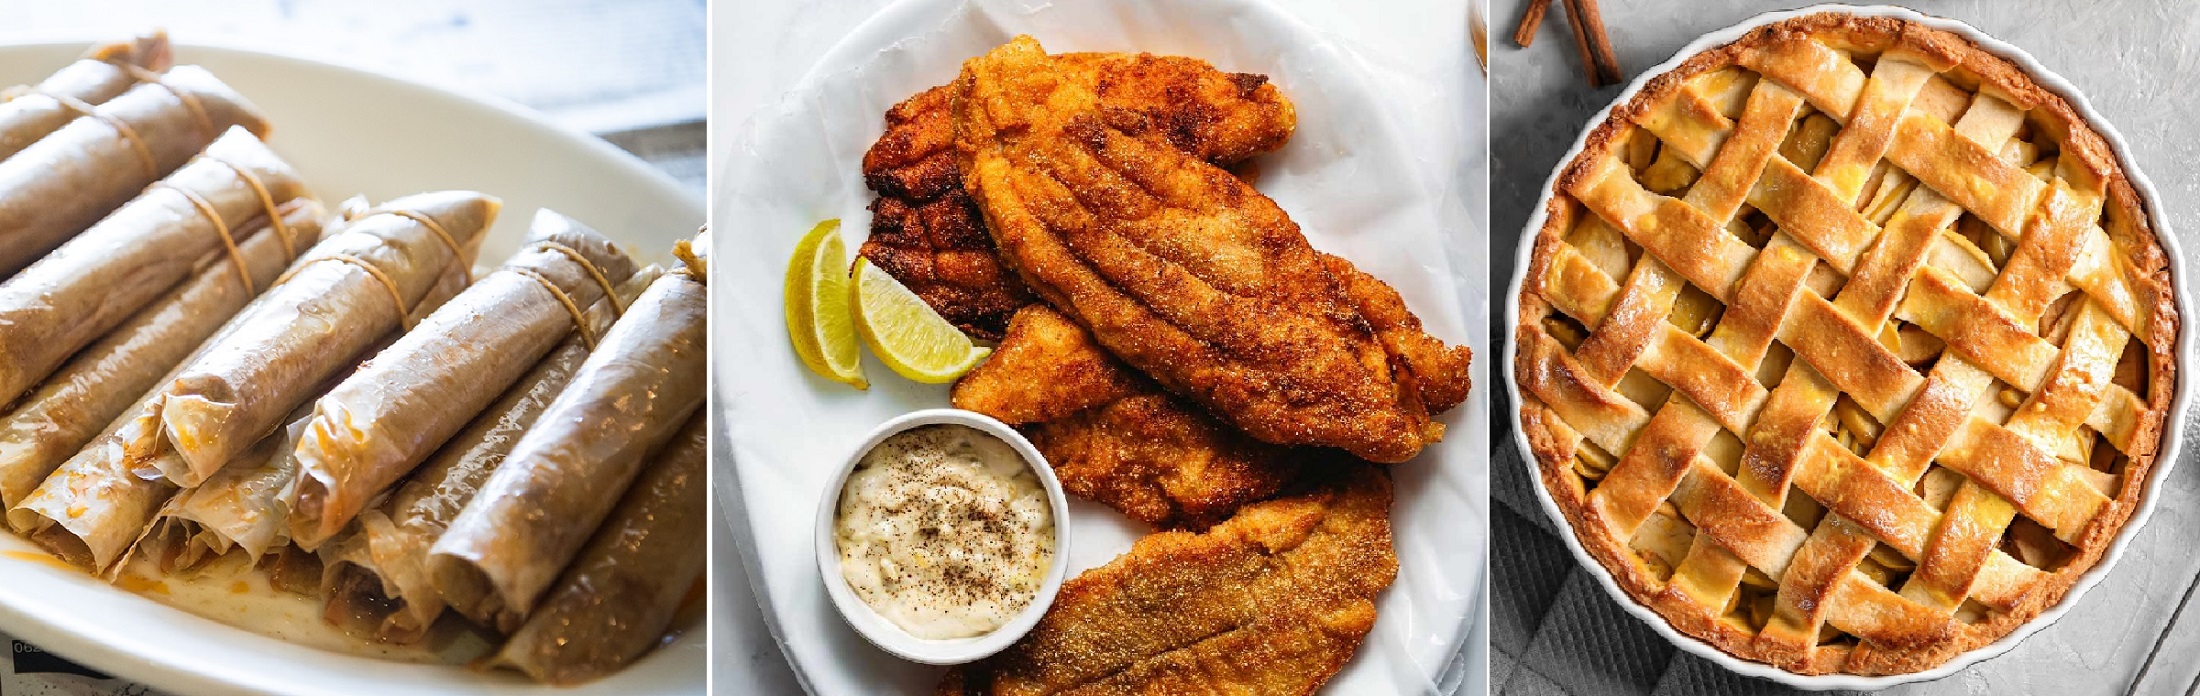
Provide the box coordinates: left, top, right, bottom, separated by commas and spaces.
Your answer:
1489, 0, 2200, 696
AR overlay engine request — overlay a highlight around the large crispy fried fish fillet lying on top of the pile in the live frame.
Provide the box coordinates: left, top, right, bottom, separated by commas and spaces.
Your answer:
955, 37, 1443, 463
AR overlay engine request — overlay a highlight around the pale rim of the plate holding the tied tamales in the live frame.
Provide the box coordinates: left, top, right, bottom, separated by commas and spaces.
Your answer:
0, 37, 708, 694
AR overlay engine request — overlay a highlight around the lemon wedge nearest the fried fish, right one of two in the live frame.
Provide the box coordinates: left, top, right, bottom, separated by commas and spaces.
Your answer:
854, 258, 992, 383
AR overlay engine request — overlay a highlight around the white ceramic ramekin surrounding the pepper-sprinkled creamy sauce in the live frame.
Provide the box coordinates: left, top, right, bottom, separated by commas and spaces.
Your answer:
816, 407, 1069, 665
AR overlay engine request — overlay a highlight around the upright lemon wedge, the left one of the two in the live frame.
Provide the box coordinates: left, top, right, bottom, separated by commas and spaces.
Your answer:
785, 220, 871, 390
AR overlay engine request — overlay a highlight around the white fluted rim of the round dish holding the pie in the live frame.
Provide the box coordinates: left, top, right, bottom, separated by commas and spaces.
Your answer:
1500, 4, 2193, 692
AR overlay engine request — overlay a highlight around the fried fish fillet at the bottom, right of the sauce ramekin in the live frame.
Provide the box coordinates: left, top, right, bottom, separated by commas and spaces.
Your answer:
937, 465, 1397, 696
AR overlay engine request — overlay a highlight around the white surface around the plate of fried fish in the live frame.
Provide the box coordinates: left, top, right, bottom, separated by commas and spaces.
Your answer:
711, 0, 1487, 694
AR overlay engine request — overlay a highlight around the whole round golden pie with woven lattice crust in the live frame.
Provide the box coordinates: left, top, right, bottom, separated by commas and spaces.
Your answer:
1514, 13, 2178, 674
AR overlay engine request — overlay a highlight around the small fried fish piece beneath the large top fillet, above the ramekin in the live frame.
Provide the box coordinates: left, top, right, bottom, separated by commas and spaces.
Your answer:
953, 304, 1302, 529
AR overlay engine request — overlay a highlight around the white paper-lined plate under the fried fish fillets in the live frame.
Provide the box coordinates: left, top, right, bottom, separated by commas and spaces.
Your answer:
711, 0, 1487, 694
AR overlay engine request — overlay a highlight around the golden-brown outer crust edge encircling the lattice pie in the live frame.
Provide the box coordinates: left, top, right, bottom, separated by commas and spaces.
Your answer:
1514, 13, 2178, 674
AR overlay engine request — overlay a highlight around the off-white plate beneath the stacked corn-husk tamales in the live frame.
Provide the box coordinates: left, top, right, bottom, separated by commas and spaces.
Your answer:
0, 40, 708, 696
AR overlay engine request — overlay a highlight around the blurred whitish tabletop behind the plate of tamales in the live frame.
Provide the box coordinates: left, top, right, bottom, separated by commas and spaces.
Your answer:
0, 0, 706, 196
